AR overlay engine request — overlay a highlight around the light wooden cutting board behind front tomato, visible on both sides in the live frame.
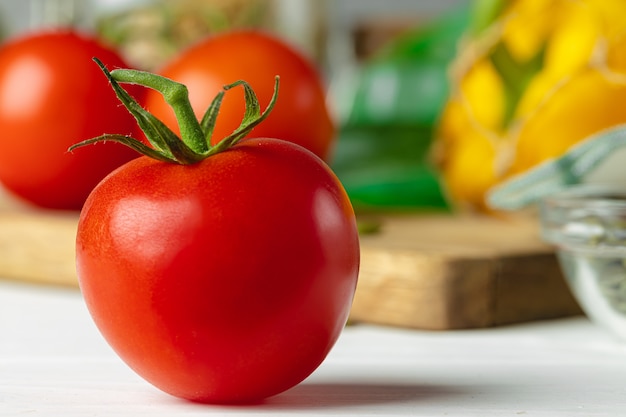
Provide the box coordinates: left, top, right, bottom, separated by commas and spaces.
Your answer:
0, 190, 580, 330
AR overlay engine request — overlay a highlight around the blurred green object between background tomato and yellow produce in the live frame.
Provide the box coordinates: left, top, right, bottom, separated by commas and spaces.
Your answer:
331, 2, 470, 210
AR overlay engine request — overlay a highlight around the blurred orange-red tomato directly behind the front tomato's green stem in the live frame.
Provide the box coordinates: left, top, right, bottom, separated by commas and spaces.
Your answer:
146, 31, 335, 160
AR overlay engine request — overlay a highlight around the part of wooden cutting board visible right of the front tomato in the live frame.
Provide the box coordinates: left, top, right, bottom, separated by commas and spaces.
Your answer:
352, 215, 580, 330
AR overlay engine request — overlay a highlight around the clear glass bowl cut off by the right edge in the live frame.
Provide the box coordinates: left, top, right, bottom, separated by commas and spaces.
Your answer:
539, 185, 626, 341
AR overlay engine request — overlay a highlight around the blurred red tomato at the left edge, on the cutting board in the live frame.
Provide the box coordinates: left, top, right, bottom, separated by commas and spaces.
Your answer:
0, 30, 143, 210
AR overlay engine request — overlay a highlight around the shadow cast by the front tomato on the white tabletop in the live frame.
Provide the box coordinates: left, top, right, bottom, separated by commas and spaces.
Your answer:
256, 382, 467, 410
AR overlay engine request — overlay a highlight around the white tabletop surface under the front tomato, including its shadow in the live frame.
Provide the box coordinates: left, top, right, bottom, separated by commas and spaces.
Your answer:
0, 280, 626, 417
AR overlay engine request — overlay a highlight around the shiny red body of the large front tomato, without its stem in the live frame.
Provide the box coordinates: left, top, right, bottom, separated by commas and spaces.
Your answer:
76, 139, 360, 403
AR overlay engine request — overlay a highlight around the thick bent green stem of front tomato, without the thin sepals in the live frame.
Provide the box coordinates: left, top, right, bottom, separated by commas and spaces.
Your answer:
111, 69, 209, 154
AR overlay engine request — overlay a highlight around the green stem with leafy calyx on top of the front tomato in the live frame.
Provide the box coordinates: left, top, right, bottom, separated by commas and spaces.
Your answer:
69, 58, 280, 165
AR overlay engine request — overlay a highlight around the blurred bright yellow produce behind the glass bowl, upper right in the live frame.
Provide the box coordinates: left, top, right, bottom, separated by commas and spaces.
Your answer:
434, 0, 626, 209
